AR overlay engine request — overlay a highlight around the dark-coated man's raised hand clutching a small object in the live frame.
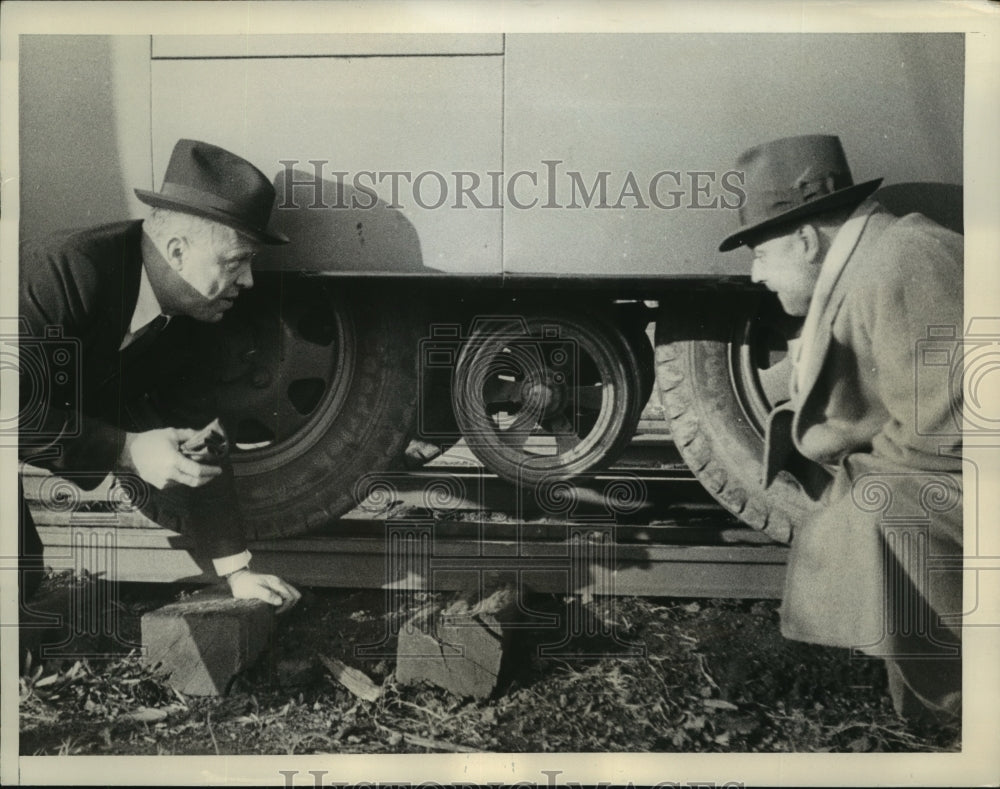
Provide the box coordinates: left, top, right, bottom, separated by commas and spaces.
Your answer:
118, 427, 222, 489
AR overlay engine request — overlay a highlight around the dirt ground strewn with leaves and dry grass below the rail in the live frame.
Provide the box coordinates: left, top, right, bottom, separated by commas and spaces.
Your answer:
20, 575, 961, 755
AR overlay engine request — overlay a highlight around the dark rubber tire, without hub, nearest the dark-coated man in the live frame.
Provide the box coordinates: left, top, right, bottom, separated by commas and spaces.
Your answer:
233, 286, 422, 539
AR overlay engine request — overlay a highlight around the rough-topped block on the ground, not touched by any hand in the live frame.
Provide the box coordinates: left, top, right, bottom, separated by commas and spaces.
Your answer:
396, 586, 520, 699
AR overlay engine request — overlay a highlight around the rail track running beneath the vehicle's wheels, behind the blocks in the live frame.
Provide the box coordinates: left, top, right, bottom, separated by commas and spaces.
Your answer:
24, 435, 787, 598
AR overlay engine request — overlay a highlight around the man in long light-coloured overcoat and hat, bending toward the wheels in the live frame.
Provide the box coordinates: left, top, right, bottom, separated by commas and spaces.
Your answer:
720, 135, 963, 720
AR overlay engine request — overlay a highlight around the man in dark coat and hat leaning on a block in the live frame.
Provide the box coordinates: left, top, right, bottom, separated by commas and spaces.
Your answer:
19, 140, 299, 609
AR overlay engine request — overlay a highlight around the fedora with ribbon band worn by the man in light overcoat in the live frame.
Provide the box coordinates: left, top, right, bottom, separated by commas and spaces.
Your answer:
719, 134, 882, 252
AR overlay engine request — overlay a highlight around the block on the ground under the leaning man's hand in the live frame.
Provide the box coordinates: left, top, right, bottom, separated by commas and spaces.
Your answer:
142, 587, 274, 696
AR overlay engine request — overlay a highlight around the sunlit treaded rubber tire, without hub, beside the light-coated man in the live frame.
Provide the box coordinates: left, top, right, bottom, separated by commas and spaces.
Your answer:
656, 295, 810, 542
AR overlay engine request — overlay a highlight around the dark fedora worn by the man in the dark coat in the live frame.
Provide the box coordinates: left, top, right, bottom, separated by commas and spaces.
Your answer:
135, 140, 288, 244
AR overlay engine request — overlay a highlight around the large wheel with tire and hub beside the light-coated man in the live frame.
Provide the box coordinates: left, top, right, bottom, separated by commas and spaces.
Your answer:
656, 296, 811, 542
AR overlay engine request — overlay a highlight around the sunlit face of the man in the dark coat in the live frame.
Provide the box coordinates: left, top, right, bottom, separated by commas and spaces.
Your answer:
177, 233, 258, 323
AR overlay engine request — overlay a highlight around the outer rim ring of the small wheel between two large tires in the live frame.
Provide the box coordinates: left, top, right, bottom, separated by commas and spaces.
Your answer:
452, 309, 645, 488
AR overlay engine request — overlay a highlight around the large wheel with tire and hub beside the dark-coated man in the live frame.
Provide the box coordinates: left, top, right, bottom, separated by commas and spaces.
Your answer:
173, 275, 420, 538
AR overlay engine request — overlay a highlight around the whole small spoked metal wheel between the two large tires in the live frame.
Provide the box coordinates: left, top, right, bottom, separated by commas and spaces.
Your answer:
452, 311, 644, 486
